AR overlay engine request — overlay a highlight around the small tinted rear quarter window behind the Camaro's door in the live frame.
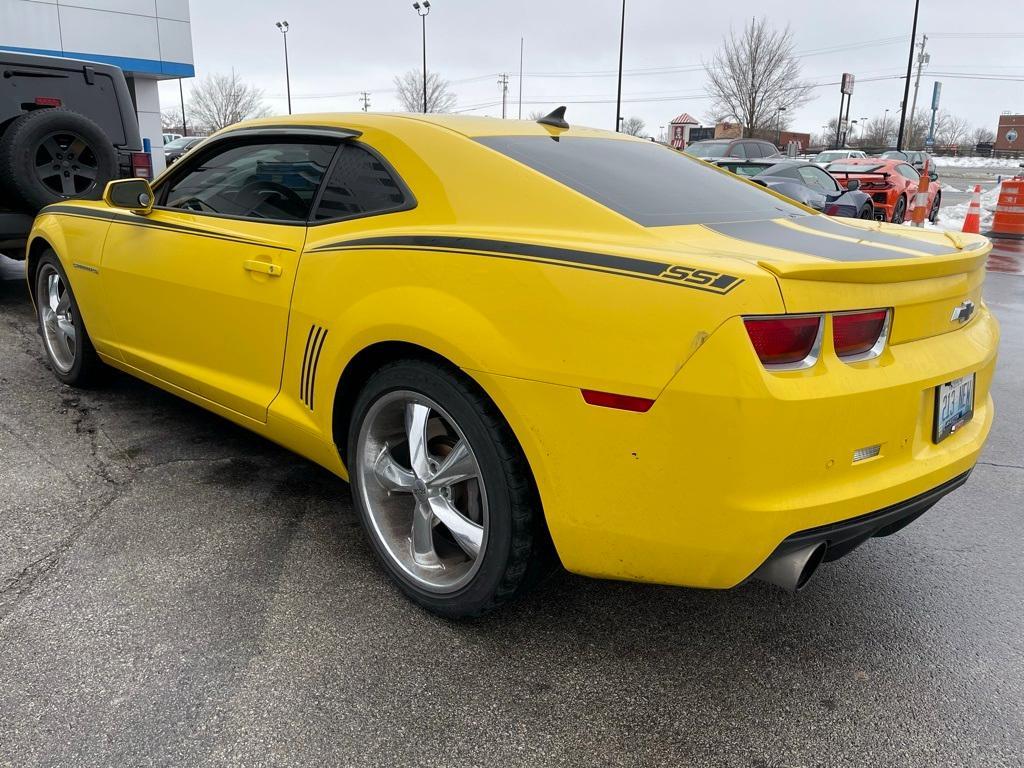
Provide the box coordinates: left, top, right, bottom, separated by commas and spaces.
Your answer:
313, 144, 411, 221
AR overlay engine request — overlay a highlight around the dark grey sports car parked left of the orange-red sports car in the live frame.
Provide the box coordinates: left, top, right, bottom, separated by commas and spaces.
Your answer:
715, 160, 874, 219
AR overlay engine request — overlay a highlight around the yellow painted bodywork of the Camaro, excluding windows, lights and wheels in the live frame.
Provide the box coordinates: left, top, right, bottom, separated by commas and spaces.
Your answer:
24, 114, 998, 588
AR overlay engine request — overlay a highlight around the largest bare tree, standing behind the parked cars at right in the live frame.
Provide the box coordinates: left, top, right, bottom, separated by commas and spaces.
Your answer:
705, 17, 812, 135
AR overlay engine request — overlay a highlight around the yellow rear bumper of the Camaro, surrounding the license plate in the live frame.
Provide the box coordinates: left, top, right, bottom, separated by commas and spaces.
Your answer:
473, 309, 998, 589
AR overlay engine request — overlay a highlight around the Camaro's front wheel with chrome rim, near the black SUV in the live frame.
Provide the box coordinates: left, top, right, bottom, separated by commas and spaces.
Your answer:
35, 251, 104, 387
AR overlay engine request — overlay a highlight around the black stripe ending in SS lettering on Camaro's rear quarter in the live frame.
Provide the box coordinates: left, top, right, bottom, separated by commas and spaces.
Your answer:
308, 234, 743, 294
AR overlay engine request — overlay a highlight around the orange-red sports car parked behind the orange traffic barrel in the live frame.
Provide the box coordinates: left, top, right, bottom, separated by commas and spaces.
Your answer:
827, 158, 942, 224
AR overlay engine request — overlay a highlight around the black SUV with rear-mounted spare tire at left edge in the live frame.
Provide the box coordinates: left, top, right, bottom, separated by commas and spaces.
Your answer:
0, 51, 146, 258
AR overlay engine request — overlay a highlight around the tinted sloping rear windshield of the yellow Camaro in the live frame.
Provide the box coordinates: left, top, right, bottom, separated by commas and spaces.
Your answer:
477, 136, 808, 226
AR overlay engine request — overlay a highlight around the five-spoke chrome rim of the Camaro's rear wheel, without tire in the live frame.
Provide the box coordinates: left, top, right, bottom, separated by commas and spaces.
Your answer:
355, 390, 487, 593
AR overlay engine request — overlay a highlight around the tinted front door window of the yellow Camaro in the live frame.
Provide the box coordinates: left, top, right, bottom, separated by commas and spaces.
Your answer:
164, 140, 336, 221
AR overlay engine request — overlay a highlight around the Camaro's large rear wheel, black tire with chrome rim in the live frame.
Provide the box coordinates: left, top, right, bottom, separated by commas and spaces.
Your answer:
347, 359, 546, 618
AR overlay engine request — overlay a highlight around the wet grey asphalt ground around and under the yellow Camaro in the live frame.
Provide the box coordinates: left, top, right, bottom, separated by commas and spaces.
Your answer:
0, 256, 1024, 768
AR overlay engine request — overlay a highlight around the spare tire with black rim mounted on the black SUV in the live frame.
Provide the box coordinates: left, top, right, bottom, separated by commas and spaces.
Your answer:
0, 109, 118, 213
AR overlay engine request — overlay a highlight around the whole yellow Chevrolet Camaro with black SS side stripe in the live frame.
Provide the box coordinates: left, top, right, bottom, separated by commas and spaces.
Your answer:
28, 111, 998, 616
